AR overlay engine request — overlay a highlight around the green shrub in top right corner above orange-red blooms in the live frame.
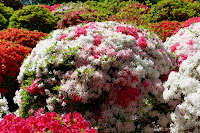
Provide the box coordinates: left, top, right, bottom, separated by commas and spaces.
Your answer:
145, 0, 200, 22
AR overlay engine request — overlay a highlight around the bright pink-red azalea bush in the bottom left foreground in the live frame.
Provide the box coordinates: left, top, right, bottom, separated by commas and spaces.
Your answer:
0, 109, 97, 133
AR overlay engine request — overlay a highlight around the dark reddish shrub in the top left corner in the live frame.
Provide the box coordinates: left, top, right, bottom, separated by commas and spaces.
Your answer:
0, 0, 23, 10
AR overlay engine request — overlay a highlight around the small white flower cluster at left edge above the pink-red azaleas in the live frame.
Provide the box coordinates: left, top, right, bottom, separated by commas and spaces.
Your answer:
0, 93, 9, 120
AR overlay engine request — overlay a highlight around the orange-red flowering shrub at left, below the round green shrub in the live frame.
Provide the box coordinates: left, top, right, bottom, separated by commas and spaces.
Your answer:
0, 28, 47, 48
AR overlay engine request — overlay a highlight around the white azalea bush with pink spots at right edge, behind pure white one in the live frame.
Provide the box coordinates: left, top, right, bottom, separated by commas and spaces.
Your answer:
163, 23, 200, 66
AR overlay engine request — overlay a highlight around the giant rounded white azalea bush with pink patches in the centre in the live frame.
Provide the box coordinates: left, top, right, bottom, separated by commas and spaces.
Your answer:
14, 21, 173, 132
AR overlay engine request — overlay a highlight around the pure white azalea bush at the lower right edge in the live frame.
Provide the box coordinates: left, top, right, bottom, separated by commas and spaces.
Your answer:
163, 50, 200, 133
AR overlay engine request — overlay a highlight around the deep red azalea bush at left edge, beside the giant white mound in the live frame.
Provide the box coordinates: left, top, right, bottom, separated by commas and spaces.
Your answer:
0, 40, 31, 111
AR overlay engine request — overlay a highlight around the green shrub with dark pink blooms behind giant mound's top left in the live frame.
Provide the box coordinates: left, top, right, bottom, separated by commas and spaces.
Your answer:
57, 8, 106, 28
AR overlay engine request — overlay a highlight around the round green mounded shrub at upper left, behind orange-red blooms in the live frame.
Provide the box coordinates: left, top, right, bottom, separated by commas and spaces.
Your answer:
9, 5, 57, 33
